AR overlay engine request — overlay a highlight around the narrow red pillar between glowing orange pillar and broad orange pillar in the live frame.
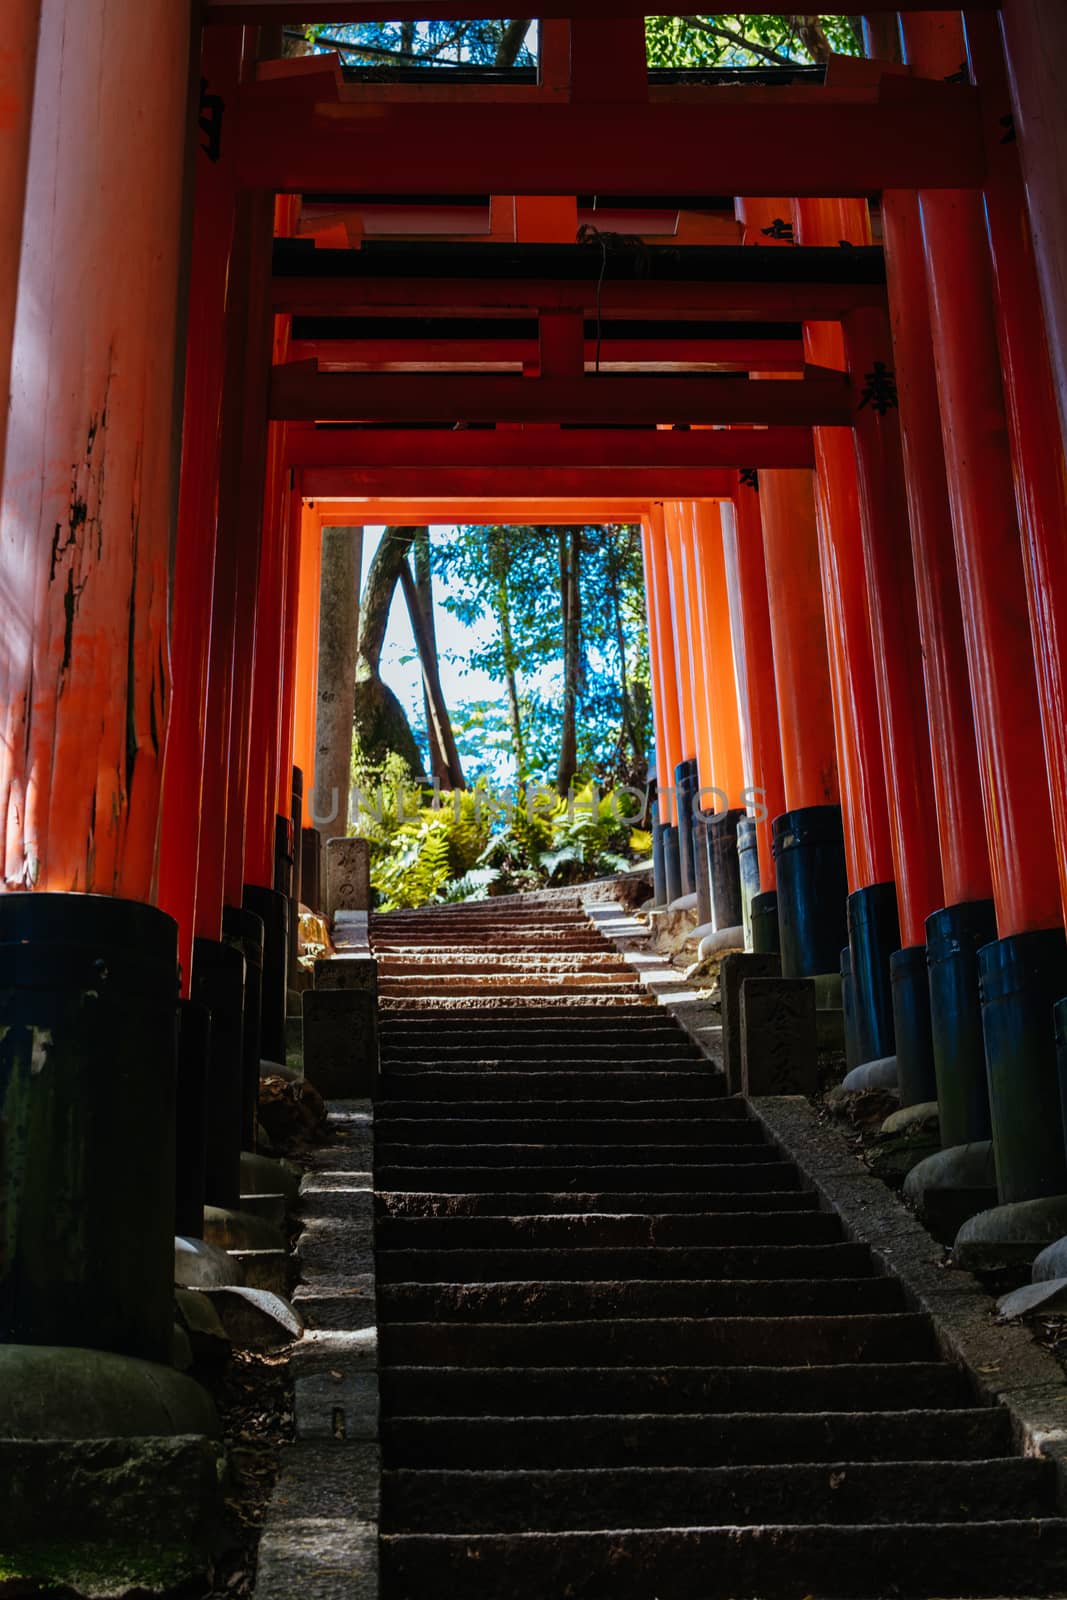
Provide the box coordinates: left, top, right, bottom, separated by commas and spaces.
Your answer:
723, 478, 785, 891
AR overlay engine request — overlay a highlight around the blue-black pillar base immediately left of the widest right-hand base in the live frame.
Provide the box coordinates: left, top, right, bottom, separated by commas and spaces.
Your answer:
926, 901, 997, 1149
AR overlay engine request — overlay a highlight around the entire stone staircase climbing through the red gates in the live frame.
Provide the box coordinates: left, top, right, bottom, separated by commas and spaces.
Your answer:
371, 894, 1067, 1600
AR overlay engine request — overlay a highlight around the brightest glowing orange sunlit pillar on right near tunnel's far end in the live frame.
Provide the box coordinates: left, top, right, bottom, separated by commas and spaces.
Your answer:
691, 501, 745, 811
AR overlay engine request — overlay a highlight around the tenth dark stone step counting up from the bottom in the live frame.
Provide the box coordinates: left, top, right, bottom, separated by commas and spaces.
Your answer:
376, 1171, 800, 1194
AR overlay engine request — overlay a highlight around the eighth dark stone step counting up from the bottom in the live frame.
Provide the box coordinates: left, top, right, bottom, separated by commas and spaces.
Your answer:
378, 1197, 841, 1250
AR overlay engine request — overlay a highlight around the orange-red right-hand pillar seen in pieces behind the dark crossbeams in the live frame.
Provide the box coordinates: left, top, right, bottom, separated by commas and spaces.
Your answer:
793, 200, 893, 891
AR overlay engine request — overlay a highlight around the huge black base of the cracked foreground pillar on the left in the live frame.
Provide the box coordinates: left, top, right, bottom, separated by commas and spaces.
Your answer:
0, 891, 178, 1356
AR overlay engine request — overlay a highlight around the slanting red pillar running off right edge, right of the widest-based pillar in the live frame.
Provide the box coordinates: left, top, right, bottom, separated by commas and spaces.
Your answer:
968, 14, 1067, 918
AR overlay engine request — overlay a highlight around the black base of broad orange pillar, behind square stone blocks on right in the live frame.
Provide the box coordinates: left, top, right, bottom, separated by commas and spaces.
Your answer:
773, 805, 848, 978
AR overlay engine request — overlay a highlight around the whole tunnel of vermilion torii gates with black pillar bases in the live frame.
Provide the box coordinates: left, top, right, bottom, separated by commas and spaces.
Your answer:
0, 0, 1067, 1355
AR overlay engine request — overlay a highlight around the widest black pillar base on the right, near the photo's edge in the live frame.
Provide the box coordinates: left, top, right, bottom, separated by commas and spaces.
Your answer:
977, 928, 1067, 1203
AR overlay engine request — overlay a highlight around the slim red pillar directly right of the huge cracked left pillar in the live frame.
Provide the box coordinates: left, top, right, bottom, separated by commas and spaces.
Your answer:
160, 27, 243, 994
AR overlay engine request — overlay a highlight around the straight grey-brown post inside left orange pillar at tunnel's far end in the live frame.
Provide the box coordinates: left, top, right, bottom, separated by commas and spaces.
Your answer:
312, 528, 363, 840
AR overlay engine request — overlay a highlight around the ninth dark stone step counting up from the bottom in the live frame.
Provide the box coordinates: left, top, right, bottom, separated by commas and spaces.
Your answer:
376, 1189, 819, 1216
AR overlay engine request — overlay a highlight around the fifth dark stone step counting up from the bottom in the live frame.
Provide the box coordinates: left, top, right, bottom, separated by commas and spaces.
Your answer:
379, 1312, 936, 1366
